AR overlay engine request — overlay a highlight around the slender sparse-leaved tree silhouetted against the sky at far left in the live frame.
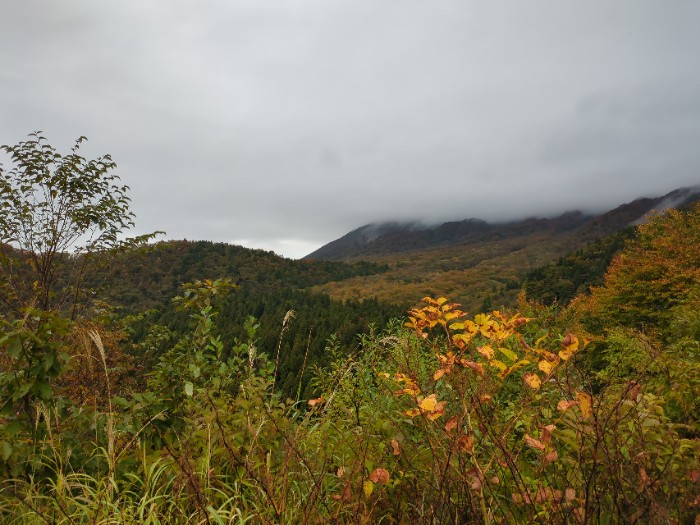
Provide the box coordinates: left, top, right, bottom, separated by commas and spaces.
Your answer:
0, 132, 160, 317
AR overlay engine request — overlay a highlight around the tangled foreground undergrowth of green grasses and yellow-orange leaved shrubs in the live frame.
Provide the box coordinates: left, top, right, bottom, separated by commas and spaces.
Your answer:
0, 281, 699, 523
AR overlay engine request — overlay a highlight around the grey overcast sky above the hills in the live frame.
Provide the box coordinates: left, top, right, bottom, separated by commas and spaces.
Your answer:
0, 0, 700, 257
